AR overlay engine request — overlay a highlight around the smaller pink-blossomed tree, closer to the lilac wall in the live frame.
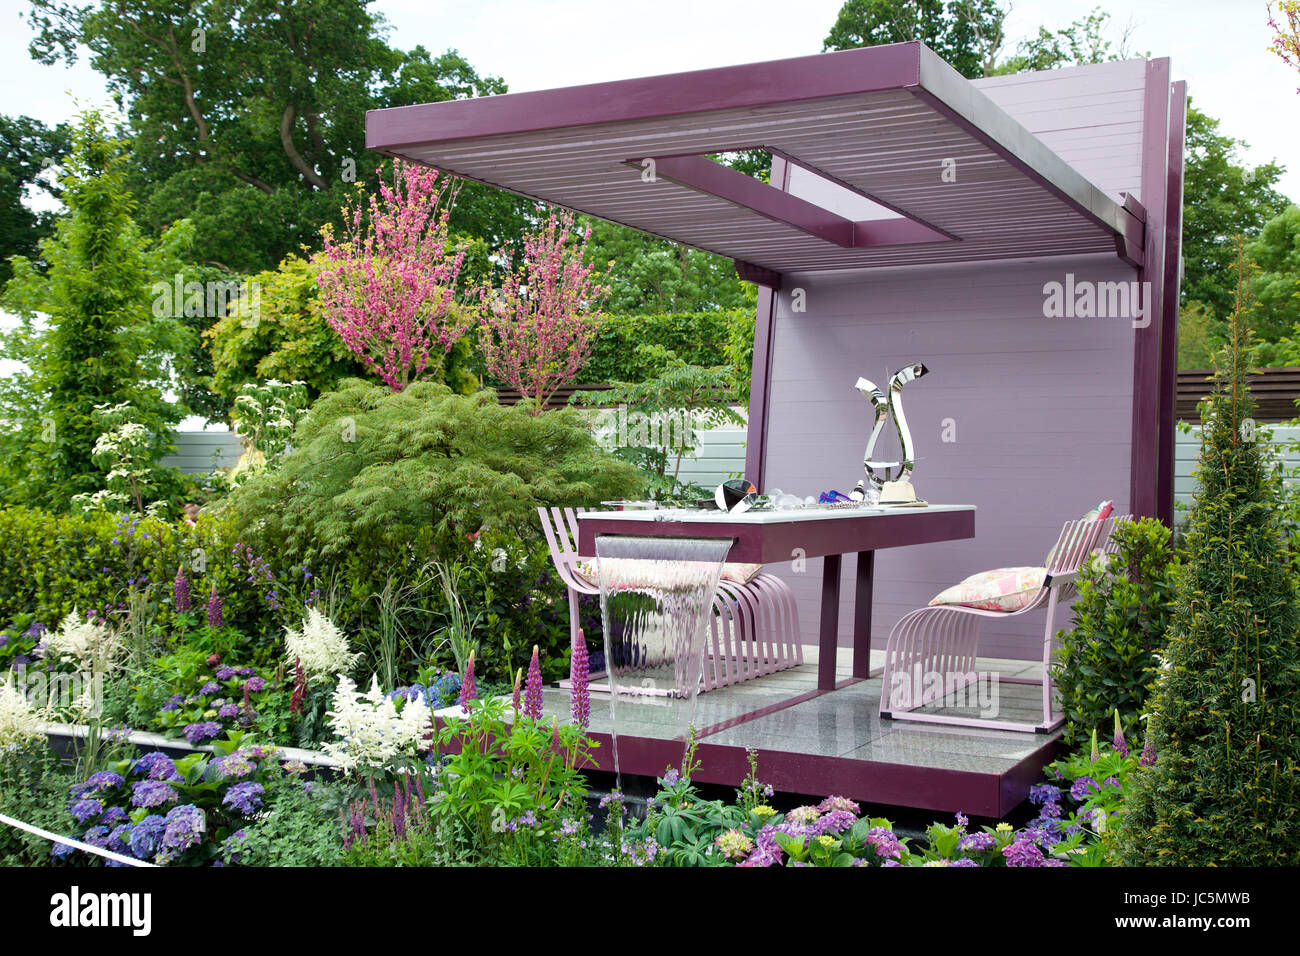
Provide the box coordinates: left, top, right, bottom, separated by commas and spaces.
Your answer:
478, 209, 608, 415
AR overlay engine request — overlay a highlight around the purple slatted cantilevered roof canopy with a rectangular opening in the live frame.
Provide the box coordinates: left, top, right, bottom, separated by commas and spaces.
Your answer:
367, 43, 1145, 277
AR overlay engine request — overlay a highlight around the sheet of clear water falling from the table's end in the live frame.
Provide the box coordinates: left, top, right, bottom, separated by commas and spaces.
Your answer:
595, 535, 732, 786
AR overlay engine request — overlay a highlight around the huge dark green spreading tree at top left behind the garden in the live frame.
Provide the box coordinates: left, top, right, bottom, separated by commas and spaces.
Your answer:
19, 0, 525, 273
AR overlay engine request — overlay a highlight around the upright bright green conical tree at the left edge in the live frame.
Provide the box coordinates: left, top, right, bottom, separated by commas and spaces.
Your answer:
0, 111, 192, 509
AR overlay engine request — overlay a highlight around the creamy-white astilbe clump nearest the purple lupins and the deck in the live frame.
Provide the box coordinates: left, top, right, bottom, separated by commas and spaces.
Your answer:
324, 675, 432, 773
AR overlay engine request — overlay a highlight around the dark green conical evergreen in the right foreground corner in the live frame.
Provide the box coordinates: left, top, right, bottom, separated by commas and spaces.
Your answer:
1119, 245, 1300, 866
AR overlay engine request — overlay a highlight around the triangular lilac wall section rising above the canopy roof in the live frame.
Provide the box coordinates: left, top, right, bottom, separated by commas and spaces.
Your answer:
972, 60, 1147, 199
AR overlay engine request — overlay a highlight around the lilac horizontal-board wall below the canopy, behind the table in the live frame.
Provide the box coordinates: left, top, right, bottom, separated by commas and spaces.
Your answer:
764, 256, 1135, 658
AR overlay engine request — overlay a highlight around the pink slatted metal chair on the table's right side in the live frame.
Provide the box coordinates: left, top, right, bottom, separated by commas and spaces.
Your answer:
880, 515, 1132, 734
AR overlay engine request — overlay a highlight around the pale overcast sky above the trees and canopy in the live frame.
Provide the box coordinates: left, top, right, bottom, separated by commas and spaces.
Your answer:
0, 0, 1300, 418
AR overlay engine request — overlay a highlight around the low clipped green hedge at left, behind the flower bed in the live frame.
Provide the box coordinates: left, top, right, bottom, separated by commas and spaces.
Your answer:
0, 507, 579, 683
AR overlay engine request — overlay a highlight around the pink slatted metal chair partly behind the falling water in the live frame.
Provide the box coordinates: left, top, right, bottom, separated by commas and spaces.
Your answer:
537, 507, 803, 692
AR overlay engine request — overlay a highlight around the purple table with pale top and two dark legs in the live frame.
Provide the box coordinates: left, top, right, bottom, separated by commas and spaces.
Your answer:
579, 505, 975, 692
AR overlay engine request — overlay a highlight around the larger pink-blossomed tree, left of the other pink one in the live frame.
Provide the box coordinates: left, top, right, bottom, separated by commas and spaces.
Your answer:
317, 160, 473, 392
